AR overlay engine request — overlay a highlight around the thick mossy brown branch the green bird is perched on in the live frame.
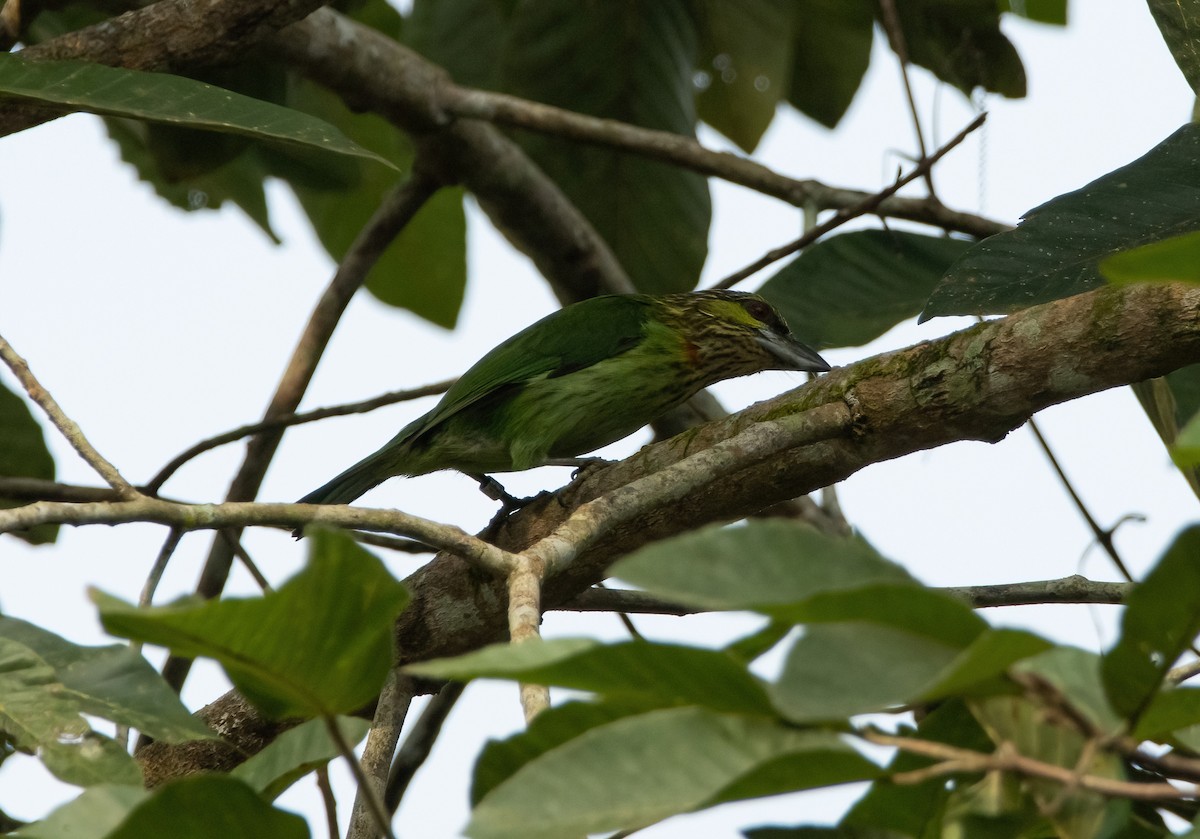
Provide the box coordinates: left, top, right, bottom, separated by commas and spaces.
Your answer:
138, 284, 1200, 787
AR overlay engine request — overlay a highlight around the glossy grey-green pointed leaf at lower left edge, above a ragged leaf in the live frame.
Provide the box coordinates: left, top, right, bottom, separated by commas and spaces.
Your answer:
0, 616, 216, 743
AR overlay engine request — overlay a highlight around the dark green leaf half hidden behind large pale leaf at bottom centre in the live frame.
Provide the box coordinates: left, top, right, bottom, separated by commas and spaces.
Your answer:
470, 701, 654, 807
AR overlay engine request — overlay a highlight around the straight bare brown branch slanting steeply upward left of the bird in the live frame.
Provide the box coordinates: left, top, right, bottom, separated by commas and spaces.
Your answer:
162, 161, 442, 689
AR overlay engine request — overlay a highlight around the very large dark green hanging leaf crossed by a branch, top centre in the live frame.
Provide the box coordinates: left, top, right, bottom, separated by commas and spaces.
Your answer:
503, 0, 712, 293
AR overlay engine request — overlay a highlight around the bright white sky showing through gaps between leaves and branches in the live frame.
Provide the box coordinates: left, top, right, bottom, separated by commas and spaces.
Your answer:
0, 1, 1196, 839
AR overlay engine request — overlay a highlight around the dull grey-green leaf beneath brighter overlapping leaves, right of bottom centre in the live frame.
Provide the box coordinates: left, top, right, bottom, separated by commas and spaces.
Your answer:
772, 623, 958, 723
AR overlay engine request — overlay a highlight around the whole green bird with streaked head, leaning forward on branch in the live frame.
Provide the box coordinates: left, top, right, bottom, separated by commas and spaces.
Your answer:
298, 290, 829, 504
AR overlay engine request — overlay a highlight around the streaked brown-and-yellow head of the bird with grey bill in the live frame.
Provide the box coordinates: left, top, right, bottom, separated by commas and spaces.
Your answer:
659, 290, 829, 378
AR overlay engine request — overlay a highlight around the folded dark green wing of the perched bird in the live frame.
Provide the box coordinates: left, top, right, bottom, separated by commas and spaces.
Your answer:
396, 294, 650, 442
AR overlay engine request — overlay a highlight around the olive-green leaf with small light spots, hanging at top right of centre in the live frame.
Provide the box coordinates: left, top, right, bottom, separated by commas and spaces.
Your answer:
696, 0, 797, 152
